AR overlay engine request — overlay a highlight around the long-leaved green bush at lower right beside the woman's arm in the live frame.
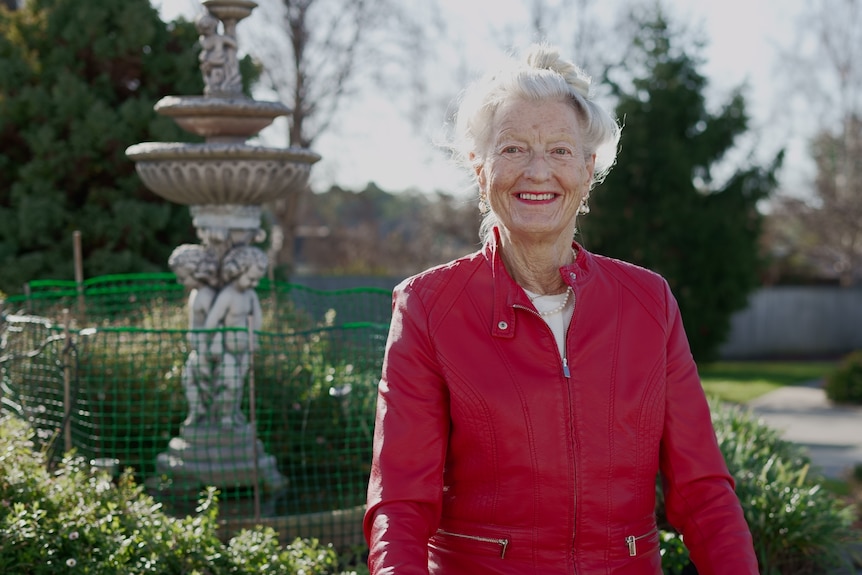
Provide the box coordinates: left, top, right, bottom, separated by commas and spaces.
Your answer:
659, 403, 859, 575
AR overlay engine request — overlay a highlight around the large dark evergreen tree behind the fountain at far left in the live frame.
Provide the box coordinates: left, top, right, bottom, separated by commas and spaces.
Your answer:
0, 0, 203, 293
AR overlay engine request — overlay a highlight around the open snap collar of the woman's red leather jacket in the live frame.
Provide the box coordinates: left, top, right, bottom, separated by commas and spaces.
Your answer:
482, 227, 595, 338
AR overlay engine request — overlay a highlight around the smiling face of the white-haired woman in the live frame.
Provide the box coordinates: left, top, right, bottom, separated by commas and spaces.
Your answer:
476, 99, 595, 242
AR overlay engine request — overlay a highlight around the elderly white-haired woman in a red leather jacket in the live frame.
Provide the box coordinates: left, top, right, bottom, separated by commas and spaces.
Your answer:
365, 42, 757, 575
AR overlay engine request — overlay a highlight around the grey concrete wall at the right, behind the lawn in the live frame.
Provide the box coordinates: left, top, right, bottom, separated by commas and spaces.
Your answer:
720, 286, 862, 359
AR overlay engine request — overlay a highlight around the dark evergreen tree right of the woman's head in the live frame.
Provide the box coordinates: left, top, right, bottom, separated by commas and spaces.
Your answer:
580, 11, 781, 361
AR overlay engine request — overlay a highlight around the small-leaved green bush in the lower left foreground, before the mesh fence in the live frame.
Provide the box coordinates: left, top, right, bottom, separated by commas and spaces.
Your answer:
0, 417, 354, 575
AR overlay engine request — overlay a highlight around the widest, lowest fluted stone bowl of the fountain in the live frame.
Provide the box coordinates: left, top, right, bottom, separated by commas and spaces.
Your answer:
126, 142, 320, 206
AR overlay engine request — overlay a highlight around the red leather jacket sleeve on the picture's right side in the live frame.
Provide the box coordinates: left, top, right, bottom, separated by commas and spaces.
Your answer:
660, 286, 758, 575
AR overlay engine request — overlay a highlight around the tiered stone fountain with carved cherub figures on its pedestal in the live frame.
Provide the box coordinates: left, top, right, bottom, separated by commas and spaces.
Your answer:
126, 0, 320, 496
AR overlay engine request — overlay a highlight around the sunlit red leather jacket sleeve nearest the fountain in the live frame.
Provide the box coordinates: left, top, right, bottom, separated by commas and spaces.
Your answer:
364, 287, 449, 575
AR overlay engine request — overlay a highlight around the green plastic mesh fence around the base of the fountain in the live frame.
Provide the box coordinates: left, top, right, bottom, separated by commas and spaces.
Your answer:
0, 274, 391, 547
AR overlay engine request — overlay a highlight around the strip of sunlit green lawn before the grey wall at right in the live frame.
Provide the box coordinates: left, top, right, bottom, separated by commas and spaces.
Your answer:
698, 361, 838, 403
